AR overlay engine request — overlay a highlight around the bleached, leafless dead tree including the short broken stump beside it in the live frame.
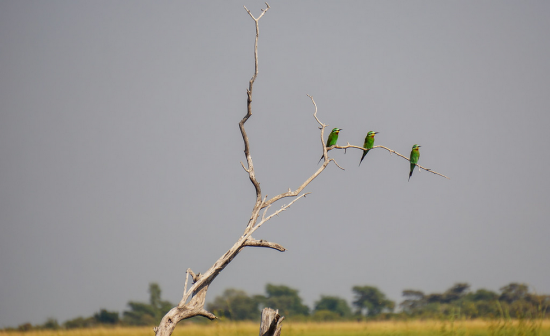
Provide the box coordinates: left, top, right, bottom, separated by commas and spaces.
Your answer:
154, 3, 446, 336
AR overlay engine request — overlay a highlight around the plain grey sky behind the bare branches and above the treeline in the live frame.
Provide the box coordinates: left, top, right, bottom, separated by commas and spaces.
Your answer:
0, 0, 550, 327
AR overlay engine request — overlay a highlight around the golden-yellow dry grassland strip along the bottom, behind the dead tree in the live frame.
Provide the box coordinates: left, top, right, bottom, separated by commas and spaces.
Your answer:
0, 320, 550, 336
